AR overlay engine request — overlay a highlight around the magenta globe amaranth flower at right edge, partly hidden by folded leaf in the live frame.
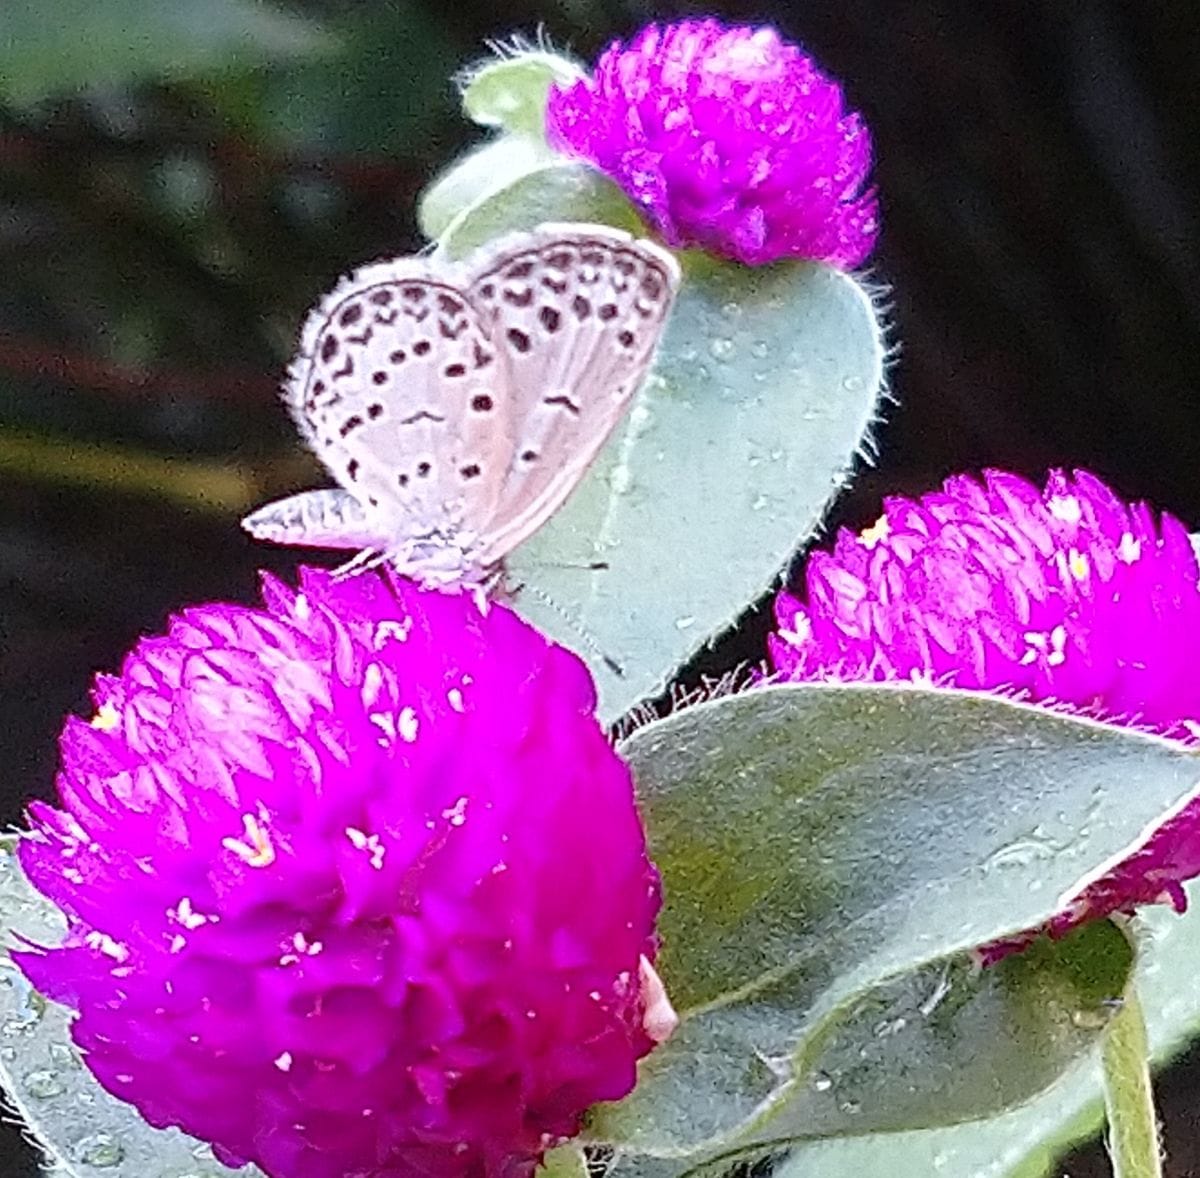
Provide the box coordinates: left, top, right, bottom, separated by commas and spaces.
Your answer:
769, 471, 1200, 932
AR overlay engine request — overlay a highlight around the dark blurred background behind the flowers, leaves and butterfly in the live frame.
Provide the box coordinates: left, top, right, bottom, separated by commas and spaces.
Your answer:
0, 0, 1200, 1178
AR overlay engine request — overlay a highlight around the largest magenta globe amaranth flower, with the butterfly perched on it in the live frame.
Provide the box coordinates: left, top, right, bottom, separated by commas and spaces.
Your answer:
16, 571, 670, 1178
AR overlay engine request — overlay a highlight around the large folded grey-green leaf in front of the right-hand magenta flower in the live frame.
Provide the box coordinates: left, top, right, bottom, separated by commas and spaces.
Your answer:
593, 684, 1200, 1161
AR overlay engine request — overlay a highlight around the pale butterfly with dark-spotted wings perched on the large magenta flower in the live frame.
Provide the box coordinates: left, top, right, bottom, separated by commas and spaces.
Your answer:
242, 224, 679, 585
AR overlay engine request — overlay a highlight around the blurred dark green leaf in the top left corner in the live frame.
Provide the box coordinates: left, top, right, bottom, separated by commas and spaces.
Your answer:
0, 0, 329, 104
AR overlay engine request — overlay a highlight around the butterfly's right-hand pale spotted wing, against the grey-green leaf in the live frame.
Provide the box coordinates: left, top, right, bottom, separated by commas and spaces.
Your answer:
467, 224, 679, 565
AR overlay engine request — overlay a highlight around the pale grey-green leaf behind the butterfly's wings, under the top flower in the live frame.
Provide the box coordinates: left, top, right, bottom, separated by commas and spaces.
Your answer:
442, 163, 884, 720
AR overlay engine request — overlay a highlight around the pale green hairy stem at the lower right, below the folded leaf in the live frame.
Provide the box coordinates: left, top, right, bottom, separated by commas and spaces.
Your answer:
1102, 982, 1163, 1178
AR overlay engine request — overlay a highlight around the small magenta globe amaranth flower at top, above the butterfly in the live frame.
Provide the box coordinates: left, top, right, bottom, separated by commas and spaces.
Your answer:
546, 20, 878, 269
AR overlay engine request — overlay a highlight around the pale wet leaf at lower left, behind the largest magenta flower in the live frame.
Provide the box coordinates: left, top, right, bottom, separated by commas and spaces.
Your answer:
0, 842, 260, 1178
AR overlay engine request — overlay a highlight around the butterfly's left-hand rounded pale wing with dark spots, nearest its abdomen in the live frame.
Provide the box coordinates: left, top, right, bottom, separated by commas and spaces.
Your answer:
288, 258, 516, 545
